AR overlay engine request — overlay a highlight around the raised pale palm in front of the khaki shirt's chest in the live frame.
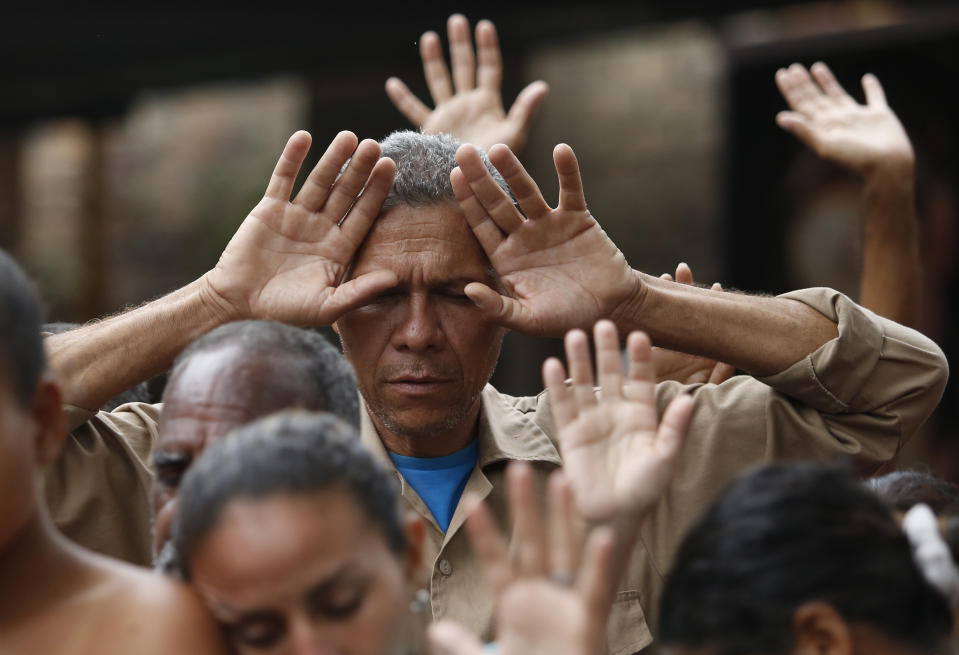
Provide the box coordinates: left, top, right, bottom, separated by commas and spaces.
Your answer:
543, 321, 693, 522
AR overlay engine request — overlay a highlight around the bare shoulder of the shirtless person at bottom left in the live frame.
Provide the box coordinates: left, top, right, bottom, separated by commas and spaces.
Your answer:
88, 558, 226, 655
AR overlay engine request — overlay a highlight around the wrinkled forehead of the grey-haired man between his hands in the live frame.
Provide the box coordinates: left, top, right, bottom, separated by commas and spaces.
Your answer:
352, 203, 490, 281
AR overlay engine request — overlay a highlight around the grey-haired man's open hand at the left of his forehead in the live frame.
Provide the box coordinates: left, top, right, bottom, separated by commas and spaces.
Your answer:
204, 131, 397, 325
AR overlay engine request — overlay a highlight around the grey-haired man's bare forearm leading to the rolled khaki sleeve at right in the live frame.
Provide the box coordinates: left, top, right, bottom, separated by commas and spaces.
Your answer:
614, 271, 838, 377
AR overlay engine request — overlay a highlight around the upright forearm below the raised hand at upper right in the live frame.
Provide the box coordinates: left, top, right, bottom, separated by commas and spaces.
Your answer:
859, 165, 921, 327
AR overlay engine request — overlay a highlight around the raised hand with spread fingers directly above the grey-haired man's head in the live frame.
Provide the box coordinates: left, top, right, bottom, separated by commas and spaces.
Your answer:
386, 14, 549, 152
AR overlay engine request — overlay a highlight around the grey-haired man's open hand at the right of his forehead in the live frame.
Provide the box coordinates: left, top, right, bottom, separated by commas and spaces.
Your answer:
450, 144, 642, 336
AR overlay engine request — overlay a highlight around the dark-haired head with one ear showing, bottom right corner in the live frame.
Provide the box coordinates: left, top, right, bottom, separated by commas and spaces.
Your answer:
660, 463, 955, 655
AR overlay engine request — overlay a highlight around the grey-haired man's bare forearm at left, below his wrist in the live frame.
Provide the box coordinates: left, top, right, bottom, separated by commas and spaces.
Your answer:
46, 279, 228, 410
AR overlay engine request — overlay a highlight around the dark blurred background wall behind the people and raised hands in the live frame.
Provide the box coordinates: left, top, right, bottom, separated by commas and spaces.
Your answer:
0, 0, 959, 481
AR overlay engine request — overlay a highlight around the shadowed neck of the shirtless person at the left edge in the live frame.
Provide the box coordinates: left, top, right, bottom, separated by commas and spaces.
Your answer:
0, 508, 89, 632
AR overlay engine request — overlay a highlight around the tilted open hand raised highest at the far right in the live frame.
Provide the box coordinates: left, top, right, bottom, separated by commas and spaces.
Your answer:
776, 62, 915, 176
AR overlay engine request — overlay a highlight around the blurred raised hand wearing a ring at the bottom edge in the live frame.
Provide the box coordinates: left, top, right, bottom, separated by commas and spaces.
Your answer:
429, 462, 617, 655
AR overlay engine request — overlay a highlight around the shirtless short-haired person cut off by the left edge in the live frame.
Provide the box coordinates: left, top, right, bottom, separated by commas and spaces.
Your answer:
0, 251, 224, 655
